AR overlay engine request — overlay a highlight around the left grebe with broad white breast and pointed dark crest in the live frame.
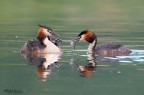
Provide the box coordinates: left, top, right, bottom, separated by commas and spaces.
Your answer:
21, 25, 61, 54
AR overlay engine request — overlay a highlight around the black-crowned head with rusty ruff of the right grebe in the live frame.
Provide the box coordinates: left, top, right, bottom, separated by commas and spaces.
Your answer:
74, 29, 96, 43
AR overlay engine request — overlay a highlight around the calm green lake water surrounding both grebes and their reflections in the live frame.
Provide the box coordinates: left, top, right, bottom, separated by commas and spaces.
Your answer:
0, 0, 144, 95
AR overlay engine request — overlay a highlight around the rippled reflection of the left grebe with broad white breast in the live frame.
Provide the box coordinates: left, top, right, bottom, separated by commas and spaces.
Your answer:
23, 53, 61, 81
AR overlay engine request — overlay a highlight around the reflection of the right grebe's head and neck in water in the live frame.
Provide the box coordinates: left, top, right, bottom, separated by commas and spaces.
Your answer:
70, 53, 97, 77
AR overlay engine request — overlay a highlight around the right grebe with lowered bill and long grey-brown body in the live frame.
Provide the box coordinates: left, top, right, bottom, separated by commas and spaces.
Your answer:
72, 29, 132, 56
